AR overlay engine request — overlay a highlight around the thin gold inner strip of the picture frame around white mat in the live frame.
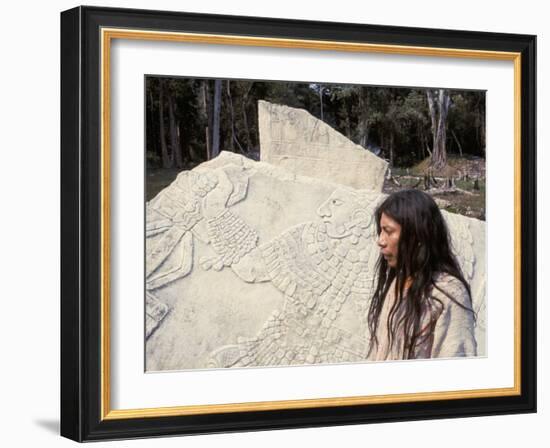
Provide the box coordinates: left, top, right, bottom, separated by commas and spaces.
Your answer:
100, 28, 521, 420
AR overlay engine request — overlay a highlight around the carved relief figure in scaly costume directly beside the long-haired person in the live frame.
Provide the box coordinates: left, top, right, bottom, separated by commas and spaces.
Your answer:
202, 188, 381, 367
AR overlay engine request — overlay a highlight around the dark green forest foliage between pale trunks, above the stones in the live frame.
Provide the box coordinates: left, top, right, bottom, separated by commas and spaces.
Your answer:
145, 77, 485, 168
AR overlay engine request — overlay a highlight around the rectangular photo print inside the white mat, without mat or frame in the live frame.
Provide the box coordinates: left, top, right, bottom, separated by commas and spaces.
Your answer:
144, 75, 487, 372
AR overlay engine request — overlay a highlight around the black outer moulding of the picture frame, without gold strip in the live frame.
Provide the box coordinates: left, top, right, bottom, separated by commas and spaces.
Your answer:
61, 7, 537, 442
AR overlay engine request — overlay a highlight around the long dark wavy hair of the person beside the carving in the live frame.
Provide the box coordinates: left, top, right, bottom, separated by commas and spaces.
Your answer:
368, 190, 475, 359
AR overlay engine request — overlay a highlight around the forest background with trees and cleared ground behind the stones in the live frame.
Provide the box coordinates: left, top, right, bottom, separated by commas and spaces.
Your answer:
145, 76, 485, 219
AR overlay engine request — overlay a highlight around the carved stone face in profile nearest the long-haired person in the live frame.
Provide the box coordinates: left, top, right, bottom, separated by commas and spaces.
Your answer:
317, 189, 358, 238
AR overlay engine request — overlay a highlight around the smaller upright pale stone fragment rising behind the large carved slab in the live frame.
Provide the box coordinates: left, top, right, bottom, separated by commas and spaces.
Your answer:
258, 101, 388, 191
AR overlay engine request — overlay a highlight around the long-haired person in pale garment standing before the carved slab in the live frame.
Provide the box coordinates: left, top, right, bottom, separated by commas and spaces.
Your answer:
368, 190, 477, 360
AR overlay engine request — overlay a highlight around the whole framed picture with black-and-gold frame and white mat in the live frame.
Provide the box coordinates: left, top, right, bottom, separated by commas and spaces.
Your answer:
61, 7, 536, 441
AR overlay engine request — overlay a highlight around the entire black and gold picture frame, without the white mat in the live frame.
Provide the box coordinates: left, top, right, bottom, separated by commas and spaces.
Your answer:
61, 7, 537, 442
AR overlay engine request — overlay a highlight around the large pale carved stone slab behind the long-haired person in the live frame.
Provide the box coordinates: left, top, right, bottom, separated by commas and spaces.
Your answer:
146, 152, 485, 371
